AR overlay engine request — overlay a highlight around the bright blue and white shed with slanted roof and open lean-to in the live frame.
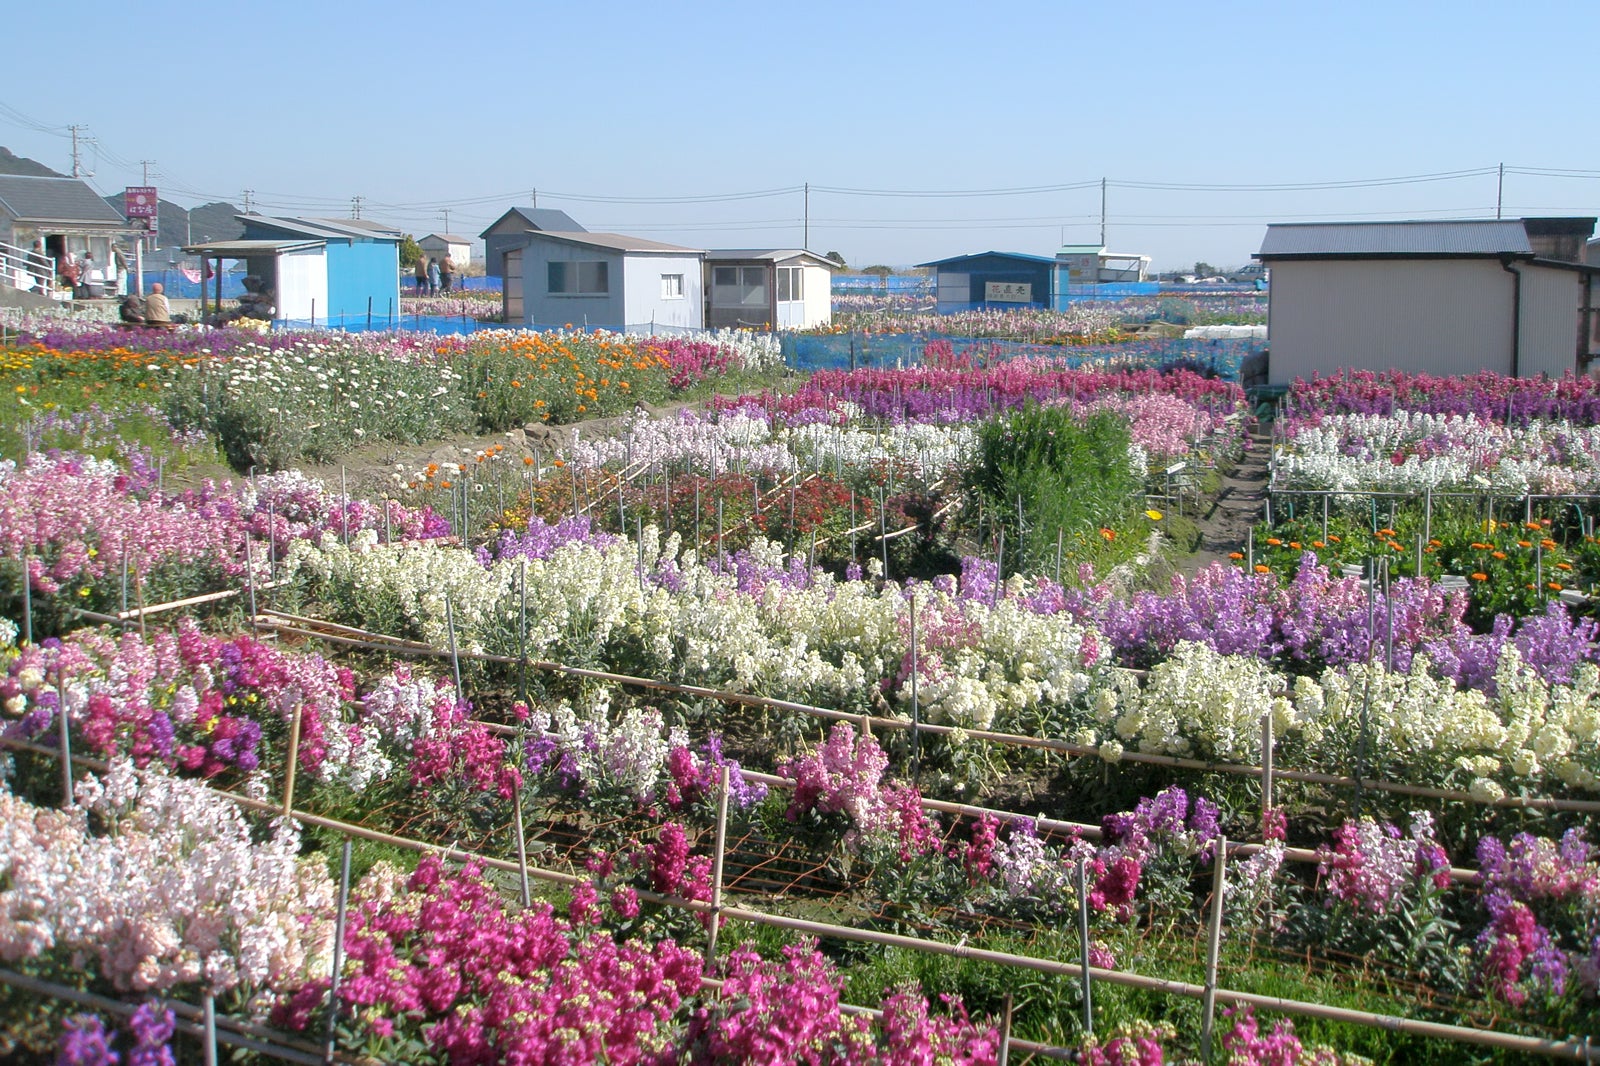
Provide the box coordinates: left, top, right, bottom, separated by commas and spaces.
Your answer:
184, 214, 402, 327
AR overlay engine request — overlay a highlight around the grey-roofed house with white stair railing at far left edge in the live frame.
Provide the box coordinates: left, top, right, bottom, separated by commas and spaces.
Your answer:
0, 174, 144, 290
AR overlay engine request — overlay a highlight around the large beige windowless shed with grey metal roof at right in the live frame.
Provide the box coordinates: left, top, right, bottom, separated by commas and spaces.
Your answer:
1256, 218, 1600, 384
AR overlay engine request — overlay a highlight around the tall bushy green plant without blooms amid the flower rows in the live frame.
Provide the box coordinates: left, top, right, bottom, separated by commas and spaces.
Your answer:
966, 407, 1142, 571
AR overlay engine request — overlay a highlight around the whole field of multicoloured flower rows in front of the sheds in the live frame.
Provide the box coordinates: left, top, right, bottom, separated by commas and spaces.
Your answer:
0, 317, 1600, 1064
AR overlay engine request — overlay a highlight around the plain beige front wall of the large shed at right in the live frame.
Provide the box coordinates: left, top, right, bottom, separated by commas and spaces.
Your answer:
1267, 259, 1510, 384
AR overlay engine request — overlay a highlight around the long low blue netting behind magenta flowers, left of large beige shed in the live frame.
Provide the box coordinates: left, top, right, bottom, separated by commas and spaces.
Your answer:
781, 333, 1262, 379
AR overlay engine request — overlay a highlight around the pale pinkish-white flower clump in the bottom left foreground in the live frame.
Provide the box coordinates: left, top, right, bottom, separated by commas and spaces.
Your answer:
0, 760, 334, 994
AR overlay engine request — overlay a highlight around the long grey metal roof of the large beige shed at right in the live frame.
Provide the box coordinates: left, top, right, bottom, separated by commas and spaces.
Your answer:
1256, 219, 1533, 259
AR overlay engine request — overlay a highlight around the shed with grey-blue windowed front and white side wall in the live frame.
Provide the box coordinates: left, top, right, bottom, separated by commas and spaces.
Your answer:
504, 230, 706, 331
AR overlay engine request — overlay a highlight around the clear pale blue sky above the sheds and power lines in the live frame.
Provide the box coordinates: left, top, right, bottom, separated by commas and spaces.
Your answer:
0, 0, 1600, 269
